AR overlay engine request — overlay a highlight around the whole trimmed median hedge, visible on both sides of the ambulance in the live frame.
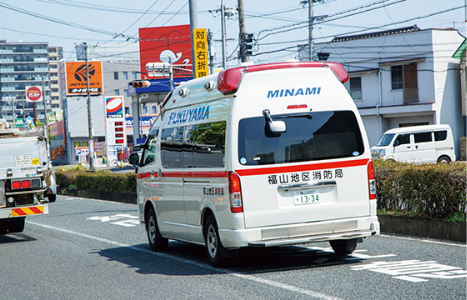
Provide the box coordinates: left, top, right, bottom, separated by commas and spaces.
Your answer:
55, 160, 467, 221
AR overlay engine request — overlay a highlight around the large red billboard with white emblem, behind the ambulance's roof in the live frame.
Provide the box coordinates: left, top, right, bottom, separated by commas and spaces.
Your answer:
139, 25, 193, 79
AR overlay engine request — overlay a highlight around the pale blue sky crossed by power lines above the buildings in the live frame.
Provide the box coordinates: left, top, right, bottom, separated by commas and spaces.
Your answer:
0, 0, 467, 67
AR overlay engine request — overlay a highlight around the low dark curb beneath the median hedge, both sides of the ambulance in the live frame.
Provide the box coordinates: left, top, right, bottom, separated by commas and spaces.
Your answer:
57, 187, 467, 242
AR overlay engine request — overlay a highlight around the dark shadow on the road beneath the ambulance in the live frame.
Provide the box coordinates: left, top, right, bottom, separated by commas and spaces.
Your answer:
95, 241, 361, 276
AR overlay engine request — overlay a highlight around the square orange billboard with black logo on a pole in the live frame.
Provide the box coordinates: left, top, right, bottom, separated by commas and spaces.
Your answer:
65, 61, 104, 96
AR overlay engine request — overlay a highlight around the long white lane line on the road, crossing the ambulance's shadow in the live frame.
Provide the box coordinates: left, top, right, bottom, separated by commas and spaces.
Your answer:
26, 221, 342, 300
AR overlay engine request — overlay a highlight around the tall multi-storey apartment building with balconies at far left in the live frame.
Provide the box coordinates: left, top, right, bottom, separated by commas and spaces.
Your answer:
0, 40, 63, 123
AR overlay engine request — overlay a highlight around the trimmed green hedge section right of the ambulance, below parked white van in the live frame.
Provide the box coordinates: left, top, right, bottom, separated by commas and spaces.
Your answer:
373, 160, 467, 219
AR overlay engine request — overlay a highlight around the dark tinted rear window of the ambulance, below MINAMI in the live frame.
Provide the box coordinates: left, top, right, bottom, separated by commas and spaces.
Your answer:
238, 111, 364, 165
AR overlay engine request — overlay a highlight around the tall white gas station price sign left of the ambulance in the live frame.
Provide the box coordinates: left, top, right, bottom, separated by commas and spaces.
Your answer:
105, 96, 127, 166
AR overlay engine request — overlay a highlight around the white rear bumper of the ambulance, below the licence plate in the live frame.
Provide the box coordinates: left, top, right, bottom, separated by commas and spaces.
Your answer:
219, 216, 380, 249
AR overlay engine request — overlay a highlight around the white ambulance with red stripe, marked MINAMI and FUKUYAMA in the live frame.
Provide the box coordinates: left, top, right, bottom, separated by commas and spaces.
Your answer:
130, 62, 380, 266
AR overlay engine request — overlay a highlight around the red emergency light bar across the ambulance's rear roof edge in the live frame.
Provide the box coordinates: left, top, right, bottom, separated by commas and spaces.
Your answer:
217, 61, 349, 95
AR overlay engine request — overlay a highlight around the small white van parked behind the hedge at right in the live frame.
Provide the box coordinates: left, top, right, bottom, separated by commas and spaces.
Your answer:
371, 125, 456, 164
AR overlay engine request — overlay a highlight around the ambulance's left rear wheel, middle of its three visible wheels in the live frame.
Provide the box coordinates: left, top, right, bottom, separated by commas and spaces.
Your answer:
204, 215, 226, 268
